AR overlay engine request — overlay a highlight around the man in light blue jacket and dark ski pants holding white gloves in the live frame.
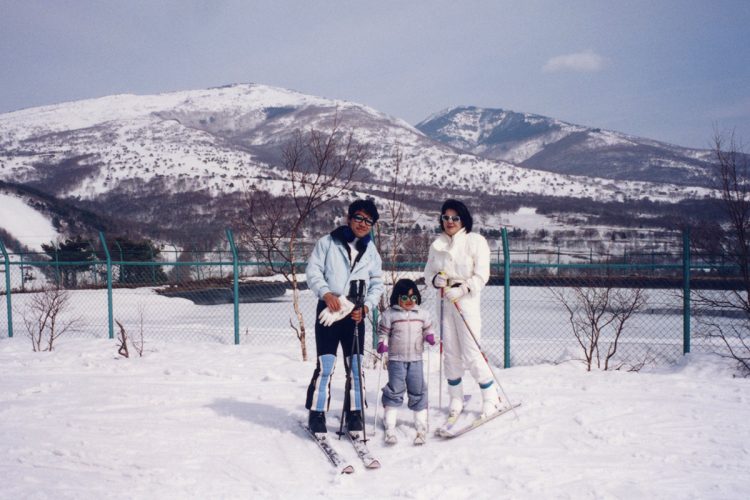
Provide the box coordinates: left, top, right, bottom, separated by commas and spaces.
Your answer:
305, 200, 383, 433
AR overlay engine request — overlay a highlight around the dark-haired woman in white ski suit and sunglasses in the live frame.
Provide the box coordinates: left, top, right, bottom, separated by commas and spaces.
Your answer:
424, 199, 499, 418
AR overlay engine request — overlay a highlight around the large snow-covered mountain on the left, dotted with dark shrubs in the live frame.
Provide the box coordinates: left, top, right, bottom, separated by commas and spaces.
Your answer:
0, 84, 712, 242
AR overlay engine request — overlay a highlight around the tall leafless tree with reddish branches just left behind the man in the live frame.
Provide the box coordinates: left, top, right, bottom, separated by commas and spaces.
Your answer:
240, 117, 367, 360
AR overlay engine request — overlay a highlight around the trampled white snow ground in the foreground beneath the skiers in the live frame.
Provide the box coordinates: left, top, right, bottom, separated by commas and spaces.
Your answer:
0, 338, 750, 499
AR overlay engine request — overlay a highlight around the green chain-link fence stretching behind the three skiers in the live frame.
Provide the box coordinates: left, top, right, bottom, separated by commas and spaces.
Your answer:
0, 232, 747, 368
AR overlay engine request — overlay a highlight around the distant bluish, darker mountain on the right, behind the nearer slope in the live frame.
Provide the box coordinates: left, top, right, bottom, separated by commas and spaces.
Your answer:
416, 106, 713, 187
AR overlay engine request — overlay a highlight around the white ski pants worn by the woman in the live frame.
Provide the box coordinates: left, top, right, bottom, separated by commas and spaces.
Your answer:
438, 297, 493, 384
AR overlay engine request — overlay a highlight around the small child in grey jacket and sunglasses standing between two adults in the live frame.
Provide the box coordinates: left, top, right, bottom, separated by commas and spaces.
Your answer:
378, 279, 435, 444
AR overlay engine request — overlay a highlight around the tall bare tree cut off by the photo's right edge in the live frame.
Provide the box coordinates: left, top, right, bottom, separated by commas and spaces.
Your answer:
693, 132, 750, 374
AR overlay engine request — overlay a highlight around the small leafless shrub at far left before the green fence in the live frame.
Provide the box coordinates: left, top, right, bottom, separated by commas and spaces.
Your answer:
21, 287, 79, 352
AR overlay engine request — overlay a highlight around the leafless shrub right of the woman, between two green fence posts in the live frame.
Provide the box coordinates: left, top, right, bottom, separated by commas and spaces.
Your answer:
549, 286, 646, 371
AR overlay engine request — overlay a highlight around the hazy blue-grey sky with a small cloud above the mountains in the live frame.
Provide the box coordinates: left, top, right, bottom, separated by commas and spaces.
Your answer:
0, 0, 750, 148
